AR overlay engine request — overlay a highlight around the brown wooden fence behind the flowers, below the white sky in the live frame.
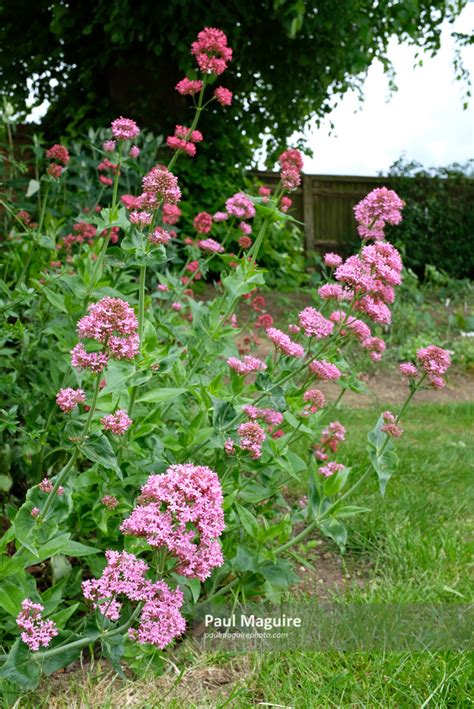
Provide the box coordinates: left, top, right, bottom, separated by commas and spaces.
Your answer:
255, 171, 391, 254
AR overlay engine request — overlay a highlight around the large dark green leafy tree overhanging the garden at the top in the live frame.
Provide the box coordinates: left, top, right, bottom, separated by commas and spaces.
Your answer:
0, 0, 467, 169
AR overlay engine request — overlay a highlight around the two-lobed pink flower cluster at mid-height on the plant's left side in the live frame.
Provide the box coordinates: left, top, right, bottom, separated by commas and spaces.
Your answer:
71, 296, 139, 372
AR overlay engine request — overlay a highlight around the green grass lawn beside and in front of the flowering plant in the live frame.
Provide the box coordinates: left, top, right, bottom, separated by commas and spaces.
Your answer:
17, 403, 474, 709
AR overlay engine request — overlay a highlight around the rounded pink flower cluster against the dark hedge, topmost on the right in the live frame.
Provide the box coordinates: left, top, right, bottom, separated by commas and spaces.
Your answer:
354, 187, 405, 239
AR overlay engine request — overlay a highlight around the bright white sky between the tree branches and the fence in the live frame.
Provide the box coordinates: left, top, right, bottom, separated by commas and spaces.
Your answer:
304, 2, 474, 175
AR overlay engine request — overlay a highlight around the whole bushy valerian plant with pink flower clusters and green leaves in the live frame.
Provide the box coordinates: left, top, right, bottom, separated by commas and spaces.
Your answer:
0, 28, 450, 689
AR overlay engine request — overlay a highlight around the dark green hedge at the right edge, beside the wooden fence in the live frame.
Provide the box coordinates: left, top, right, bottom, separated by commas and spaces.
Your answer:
389, 160, 474, 278
